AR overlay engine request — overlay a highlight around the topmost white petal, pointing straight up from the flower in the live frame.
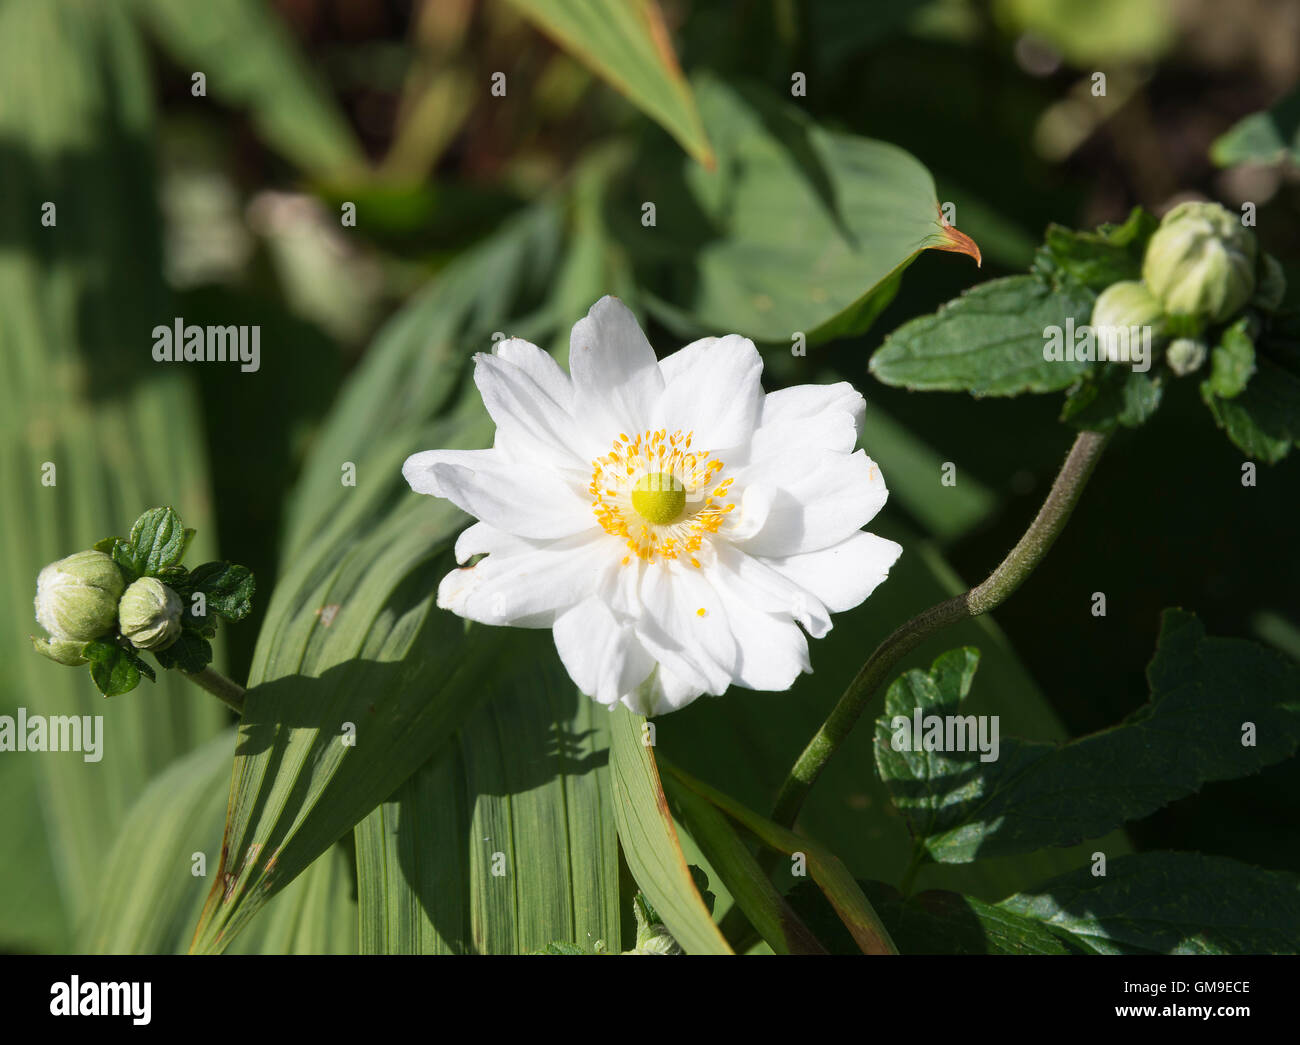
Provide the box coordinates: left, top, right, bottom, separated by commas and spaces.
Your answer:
569, 296, 663, 439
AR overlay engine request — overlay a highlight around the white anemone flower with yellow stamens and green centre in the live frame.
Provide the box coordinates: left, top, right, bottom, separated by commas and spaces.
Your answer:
402, 296, 902, 715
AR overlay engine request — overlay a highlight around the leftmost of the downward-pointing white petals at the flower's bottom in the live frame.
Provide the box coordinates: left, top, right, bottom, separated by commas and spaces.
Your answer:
555, 597, 654, 704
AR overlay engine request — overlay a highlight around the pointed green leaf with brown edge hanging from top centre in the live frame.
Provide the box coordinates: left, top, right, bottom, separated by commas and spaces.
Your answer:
511, 0, 714, 168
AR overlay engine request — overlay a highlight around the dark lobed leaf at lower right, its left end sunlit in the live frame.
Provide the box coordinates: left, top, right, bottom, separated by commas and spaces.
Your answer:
876, 610, 1300, 863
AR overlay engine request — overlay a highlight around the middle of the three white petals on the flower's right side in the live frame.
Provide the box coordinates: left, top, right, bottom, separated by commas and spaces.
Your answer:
737, 450, 889, 556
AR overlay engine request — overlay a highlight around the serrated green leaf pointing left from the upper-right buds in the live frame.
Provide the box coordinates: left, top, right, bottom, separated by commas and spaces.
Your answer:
871, 276, 1097, 395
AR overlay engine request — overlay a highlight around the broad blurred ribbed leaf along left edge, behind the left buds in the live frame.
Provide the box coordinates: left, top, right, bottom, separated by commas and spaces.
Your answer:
0, 0, 225, 924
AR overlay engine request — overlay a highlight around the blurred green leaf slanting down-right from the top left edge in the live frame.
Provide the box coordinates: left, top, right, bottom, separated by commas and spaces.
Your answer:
134, 0, 364, 177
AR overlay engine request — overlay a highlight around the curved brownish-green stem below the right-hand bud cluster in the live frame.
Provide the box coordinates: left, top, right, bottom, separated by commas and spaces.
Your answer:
772, 432, 1109, 827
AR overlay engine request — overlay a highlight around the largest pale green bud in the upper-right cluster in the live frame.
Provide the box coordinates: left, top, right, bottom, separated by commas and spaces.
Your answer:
1141, 203, 1256, 322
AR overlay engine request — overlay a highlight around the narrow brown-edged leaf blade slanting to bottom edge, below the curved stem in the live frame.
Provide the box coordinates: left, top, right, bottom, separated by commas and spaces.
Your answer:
668, 767, 897, 954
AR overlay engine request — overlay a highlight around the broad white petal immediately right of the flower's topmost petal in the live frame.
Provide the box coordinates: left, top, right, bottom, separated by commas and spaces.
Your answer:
650, 334, 763, 450
